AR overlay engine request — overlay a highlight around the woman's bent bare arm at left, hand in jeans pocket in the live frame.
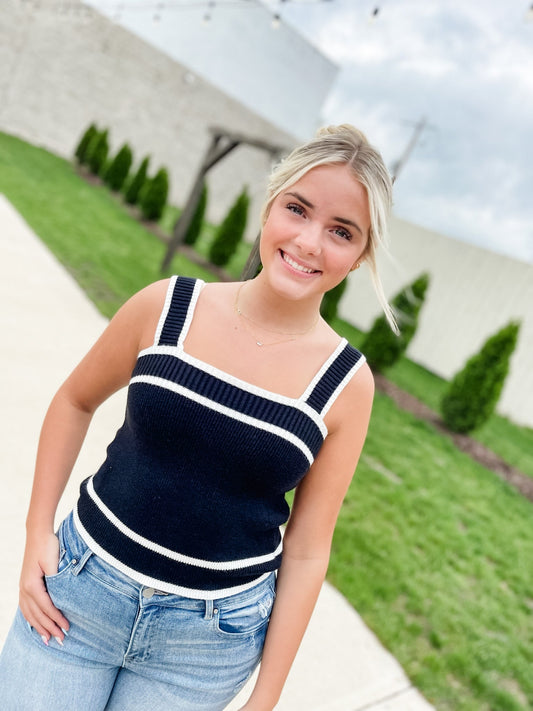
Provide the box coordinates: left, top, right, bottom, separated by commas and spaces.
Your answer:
19, 282, 166, 642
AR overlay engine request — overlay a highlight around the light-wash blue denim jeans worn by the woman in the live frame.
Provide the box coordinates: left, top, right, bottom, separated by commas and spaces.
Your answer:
0, 514, 275, 711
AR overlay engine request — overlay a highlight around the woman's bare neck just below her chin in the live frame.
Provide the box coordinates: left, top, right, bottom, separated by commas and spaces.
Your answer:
238, 274, 320, 334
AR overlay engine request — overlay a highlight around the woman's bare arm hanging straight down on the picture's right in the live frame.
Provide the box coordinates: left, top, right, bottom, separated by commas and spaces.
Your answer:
242, 366, 374, 711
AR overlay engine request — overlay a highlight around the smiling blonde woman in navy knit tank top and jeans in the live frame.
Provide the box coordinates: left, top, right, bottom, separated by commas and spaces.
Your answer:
0, 125, 395, 711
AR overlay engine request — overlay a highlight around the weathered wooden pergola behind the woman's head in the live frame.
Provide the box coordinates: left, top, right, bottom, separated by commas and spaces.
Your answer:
161, 126, 287, 278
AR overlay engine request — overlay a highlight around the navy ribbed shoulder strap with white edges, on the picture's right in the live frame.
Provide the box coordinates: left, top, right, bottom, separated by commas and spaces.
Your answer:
306, 339, 366, 417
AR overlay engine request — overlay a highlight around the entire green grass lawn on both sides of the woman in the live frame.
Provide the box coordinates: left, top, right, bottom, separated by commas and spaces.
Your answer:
0, 134, 533, 711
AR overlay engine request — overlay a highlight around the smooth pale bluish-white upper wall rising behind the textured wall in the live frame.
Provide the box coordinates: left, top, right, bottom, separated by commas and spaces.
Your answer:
86, 0, 338, 139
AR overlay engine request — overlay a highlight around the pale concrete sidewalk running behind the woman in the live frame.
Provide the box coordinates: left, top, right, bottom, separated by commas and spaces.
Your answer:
0, 195, 433, 711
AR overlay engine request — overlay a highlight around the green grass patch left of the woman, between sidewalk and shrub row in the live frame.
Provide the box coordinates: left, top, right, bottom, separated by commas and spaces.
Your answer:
0, 134, 213, 317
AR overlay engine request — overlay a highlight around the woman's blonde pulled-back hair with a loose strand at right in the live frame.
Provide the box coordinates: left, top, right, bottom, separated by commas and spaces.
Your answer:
261, 123, 398, 333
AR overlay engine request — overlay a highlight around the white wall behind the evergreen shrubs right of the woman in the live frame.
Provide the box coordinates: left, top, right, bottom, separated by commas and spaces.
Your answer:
341, 219, 533, 427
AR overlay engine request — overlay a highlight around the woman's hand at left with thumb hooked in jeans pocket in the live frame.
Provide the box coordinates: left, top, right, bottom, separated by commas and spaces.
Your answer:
19, 533, 69, 644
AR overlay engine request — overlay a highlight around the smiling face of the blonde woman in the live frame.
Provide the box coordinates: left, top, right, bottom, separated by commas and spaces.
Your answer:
261, 164, 370, 298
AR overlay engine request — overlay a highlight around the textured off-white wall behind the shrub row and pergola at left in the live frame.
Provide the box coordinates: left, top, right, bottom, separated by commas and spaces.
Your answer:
0, 0, 308, 237
